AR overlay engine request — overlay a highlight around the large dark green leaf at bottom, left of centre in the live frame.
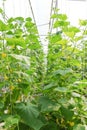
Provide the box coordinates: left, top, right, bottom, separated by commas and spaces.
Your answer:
16, 103, 44, 130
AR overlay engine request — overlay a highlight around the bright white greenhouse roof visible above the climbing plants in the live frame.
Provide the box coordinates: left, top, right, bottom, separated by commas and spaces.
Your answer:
0, 0, 87, 51
